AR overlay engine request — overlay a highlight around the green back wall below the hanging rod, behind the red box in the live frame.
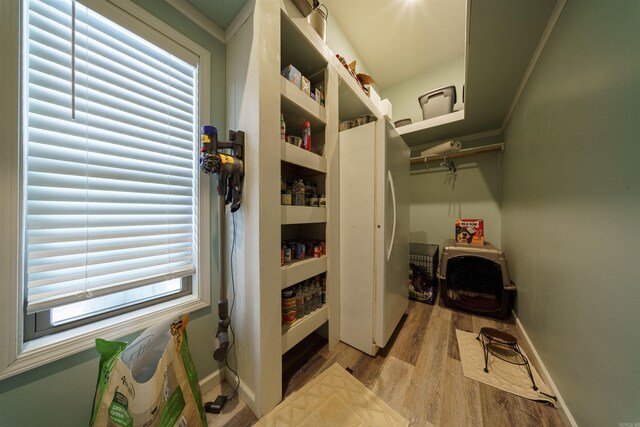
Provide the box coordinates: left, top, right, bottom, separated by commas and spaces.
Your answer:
409, 152, 502, 250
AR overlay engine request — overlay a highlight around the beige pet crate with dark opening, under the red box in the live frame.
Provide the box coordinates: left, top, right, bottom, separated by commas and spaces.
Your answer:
438, 239, 516, 319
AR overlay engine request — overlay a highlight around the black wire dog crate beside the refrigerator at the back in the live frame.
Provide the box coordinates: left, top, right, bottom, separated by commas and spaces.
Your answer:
409, 243, 439, 304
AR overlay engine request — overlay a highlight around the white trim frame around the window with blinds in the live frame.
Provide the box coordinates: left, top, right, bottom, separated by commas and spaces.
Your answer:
0, 0, 211, 380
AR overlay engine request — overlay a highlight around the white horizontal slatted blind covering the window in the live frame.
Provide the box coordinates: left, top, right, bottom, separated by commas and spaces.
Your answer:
24, 0, 198, 314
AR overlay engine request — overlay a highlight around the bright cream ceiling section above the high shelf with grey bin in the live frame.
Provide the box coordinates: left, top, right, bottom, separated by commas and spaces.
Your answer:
321, 0, 467, 89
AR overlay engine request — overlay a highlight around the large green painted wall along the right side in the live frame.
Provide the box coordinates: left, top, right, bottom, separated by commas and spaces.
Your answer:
502, 0, 640, 426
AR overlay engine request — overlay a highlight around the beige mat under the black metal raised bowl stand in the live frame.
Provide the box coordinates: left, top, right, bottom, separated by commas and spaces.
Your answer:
456, 330, 556, 406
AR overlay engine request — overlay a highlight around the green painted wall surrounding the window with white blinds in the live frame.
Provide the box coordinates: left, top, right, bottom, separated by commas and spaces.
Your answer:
0, 0, 225, 427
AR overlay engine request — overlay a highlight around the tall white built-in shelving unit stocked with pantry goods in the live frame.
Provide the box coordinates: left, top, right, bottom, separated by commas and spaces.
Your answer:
226, 0, 381, 417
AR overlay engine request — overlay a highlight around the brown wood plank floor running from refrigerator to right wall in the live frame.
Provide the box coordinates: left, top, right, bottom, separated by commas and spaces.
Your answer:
204, 301, 563, 427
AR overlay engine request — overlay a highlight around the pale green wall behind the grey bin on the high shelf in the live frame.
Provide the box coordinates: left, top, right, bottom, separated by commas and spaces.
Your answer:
380, 55, 464, 123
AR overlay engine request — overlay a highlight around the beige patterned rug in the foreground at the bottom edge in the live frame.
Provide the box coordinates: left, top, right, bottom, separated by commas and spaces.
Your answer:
255, 363, 409, 427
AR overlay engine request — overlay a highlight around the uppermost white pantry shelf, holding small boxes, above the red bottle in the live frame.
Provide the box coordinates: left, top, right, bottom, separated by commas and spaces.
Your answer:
280, 76, 327, 132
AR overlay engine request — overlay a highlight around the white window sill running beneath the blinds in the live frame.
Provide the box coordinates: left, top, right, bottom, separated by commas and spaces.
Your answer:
0, 295, 210, 380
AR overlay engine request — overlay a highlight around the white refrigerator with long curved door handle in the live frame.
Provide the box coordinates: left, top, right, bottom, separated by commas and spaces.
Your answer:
339, 120, 409, 356
